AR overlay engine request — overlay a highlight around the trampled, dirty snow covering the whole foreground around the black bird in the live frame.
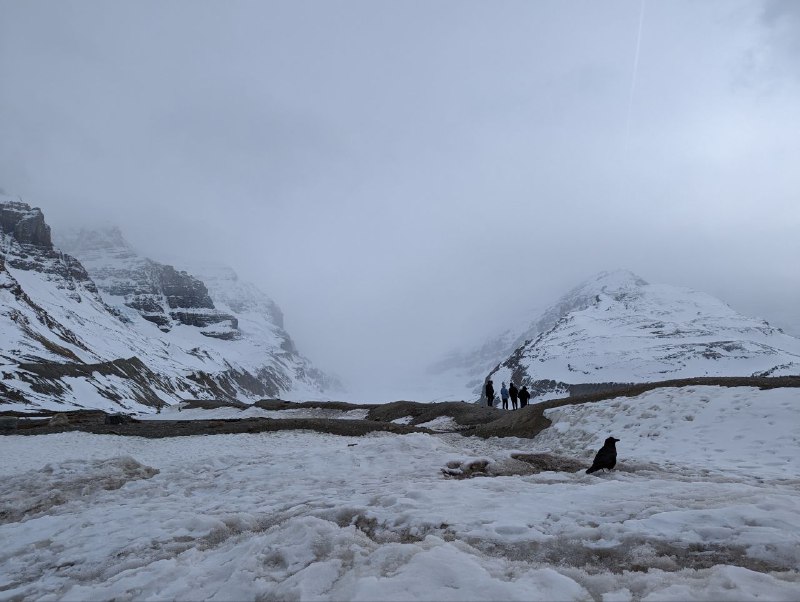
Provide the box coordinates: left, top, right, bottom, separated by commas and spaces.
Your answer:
0, 387, 800, 602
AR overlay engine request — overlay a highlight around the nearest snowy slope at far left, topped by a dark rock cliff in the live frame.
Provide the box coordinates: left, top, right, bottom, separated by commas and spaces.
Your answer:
0, 197, 190, 408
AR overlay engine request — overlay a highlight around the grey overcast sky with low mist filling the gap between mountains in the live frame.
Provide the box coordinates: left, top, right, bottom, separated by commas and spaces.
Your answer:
0, 0, 800, 396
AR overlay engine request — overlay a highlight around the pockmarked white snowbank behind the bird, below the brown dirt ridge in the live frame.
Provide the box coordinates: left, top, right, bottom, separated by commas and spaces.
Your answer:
536, 387, 800, 478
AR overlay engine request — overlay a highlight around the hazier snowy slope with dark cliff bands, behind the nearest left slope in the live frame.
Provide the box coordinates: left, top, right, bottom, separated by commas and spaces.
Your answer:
59, 228, 340, 400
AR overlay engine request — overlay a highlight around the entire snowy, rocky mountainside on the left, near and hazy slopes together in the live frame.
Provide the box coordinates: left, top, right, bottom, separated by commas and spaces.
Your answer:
0, 196, 338, 409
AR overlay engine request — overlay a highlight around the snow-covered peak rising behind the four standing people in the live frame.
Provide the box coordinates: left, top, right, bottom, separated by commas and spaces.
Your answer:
430, 270, 800, 399
